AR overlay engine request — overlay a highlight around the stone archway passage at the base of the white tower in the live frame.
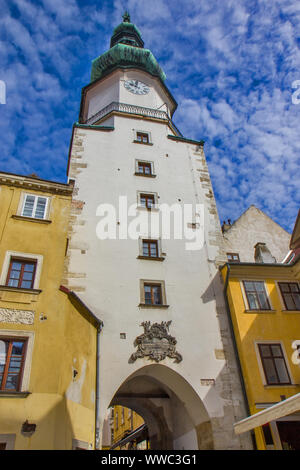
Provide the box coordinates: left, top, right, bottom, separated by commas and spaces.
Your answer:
105, 364, 214, 450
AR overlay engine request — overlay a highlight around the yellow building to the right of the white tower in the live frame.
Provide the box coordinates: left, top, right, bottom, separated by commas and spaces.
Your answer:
221, 248, 300, 449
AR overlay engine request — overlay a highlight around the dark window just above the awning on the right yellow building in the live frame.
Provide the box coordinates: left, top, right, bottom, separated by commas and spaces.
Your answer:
258, 343, 291, 385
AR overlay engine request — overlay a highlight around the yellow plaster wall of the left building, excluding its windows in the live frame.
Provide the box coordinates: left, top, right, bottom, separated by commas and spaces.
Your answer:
0, 185, 96, 450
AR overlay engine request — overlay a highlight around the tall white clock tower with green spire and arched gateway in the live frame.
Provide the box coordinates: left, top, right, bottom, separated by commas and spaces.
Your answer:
64, 13, 251, 449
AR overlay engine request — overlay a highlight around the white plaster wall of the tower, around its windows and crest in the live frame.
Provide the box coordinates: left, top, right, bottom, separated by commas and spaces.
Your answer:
66, 112, 250, 448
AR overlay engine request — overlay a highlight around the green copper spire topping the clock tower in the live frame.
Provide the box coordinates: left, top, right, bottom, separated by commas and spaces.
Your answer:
91, 11, 166, 82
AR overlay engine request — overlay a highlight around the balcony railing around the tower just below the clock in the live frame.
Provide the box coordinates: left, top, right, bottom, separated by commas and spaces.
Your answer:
85, 101, 182, 135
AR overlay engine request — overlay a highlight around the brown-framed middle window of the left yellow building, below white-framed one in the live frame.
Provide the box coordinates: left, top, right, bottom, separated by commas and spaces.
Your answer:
6, 258, 37, 289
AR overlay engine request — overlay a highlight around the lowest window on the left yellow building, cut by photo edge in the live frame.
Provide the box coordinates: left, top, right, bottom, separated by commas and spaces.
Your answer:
0, 338, 27, 391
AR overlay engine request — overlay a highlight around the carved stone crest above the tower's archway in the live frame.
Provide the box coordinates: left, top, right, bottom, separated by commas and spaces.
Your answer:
129, 320, 182, 363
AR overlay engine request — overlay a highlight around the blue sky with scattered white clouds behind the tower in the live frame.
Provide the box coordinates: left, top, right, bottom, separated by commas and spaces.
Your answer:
0, 0, 300, 231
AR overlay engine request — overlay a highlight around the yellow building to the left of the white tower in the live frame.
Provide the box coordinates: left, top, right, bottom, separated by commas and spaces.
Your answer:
0, 173, 101, 450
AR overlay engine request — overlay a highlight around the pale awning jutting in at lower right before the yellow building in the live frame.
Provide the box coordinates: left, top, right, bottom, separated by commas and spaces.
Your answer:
233, 393, 300, 434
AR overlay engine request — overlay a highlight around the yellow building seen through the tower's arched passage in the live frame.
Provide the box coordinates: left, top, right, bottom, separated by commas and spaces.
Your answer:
111, 406, 149, 450
